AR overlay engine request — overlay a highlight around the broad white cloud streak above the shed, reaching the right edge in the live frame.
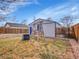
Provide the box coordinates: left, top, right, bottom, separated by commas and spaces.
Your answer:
35, 4, 79, 19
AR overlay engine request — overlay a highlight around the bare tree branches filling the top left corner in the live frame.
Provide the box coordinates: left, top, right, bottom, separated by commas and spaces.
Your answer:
0, 0, 29, 21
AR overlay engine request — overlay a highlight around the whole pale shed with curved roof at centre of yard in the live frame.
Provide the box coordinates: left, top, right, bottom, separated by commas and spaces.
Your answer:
29, 18, 61, 38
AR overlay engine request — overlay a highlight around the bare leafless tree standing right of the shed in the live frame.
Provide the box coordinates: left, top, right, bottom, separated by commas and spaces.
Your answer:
60, 16, 73, 37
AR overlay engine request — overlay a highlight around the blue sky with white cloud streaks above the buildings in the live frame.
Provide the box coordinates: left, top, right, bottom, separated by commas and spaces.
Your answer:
0, 0, 79, 25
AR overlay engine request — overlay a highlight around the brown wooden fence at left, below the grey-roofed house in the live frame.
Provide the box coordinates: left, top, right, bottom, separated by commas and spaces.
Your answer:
0, 28, 28, 34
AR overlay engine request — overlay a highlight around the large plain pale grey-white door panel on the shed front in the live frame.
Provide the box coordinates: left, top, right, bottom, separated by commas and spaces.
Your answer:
43, 23, 55, 37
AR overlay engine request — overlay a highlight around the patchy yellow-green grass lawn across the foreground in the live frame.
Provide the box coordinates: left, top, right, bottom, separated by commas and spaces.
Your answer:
0, 37, 72, 59
